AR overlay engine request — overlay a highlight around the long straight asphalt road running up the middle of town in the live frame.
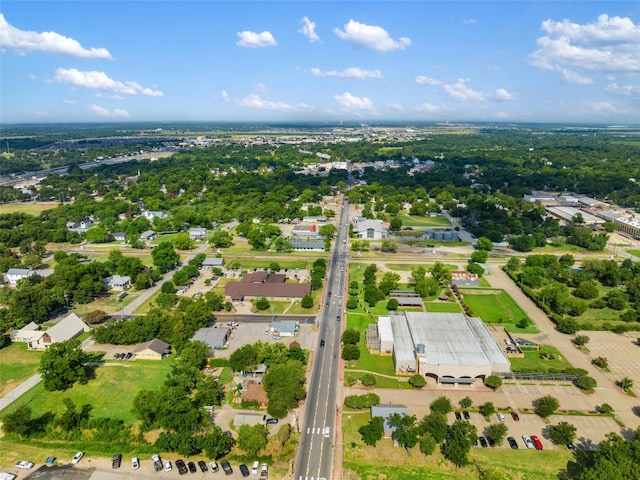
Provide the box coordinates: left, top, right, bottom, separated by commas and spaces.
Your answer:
293, 202, 348, 480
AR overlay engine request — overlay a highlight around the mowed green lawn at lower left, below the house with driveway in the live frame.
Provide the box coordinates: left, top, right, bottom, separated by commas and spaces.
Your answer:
0, 356, 174, 423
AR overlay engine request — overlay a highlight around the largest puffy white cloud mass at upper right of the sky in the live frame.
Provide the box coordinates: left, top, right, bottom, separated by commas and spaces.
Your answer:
530, 14, 640, 72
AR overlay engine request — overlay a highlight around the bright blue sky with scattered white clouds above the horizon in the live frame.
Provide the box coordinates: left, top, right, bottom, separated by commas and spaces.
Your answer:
0, 0, 640, 124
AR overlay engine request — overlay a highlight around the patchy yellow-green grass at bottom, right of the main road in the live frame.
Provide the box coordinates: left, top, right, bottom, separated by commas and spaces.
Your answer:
342, 412, 571, 480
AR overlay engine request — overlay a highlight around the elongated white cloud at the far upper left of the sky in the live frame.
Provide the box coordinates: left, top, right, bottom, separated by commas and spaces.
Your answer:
0, 13, 111, 58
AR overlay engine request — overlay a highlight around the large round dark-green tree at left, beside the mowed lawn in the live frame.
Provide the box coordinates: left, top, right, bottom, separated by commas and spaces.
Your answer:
38, 339, 89, 391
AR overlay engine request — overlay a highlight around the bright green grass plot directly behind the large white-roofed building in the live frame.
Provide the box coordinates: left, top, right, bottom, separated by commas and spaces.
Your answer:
463, 290, 538, 333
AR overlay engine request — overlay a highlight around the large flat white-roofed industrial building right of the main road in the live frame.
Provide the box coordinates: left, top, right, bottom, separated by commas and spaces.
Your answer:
378, 312, 510, 384
